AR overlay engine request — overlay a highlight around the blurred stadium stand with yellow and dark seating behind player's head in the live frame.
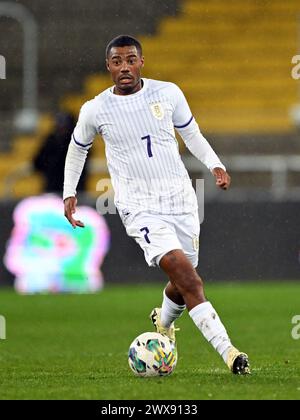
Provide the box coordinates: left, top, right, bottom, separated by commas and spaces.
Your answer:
0, 0, 300, 196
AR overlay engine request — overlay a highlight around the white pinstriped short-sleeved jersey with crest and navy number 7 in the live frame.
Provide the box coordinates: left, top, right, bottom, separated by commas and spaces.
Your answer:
66, 79, 222, 217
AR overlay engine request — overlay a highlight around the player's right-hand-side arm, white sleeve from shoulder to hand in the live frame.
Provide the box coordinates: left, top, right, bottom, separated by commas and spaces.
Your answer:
173, 86, 230, 190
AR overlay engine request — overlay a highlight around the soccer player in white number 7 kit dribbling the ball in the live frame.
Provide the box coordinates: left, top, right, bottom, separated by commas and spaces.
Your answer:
63, 35, 250, 374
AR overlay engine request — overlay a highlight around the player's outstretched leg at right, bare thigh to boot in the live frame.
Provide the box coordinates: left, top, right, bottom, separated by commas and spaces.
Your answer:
160, 250, 250, 374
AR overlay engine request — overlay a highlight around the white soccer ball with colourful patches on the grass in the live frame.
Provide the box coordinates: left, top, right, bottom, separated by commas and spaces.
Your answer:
128, 332, 177, 376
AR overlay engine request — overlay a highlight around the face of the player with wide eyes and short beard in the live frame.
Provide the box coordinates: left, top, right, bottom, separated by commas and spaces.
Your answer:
106, 46, 144, 95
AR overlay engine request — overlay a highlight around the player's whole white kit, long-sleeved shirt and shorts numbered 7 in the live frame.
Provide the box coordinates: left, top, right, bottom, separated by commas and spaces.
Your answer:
63, 78, 225, 267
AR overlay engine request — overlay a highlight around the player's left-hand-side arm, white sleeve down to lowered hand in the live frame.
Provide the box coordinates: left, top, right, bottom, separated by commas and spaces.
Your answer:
63, 101, 96, 228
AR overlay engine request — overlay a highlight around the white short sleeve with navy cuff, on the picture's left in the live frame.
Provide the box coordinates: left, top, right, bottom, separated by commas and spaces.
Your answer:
72, 100, 97, 150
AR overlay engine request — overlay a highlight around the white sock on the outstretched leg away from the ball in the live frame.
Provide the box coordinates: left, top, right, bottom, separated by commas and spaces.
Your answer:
189, 302, 232, 363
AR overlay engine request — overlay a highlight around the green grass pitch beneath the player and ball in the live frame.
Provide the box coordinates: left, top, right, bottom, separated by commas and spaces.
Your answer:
0, 282, 300, 400
